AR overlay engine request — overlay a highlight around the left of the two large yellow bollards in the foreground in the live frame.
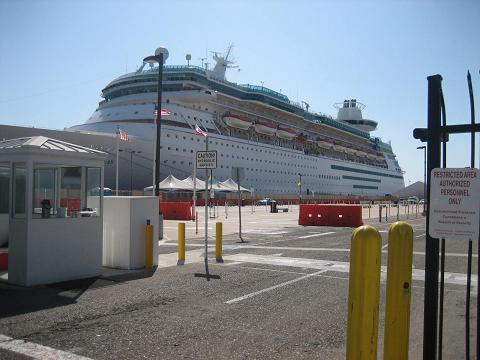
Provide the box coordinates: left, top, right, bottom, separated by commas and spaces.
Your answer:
346, 225, 382, 360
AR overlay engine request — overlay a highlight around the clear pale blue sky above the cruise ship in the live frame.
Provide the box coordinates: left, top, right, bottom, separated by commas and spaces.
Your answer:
0, 0, 480, 185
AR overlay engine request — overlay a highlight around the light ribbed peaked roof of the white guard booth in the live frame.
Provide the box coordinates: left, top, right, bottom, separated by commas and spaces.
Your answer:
0, 136, 106, 155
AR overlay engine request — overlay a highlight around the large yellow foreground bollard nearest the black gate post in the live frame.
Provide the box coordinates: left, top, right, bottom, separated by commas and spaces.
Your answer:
383, 221, 413, 360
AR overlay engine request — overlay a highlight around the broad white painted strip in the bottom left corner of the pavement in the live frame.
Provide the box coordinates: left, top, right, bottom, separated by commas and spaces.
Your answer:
0, 334, 91, 360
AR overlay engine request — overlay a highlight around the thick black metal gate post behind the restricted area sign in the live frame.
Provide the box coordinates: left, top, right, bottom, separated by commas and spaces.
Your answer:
423, 75, 442, 359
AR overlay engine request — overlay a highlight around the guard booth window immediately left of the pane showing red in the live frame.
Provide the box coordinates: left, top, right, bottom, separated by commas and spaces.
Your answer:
33, 168, 57, 219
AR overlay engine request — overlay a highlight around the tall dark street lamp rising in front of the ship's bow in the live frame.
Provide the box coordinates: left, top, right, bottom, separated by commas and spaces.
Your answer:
143, 46, 168, 196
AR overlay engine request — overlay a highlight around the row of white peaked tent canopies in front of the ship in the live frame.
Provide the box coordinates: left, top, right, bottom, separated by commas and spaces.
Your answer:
143, 174, 250, 192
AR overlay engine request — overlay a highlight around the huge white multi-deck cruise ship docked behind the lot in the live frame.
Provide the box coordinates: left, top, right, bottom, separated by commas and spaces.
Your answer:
0, 47, 404, 198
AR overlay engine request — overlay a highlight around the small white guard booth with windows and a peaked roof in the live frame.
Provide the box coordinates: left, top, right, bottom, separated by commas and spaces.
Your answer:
0, 136, 106, 286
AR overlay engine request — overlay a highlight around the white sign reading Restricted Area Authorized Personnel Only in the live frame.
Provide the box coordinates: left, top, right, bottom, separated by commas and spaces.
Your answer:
428, 168, 480, 240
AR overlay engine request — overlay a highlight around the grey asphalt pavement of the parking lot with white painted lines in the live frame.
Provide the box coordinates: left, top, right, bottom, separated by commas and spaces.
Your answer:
0, 206, 478, 359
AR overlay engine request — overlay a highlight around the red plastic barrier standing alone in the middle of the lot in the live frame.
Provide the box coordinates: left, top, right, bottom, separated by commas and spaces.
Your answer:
298, 204, 363, 227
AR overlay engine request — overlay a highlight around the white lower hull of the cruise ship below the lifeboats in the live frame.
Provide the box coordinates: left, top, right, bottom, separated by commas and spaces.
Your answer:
0, 123, 404, 198
